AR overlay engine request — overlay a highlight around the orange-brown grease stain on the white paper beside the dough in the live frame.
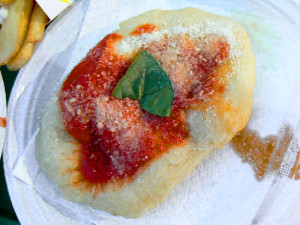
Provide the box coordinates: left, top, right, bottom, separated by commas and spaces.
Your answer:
231, 127, 293, 180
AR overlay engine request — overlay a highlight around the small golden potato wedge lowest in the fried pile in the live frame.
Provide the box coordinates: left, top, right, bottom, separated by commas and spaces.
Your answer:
6, 41, 34, 71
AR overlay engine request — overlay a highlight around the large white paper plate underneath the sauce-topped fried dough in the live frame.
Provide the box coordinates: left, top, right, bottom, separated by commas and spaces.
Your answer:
4, 0, 300, 225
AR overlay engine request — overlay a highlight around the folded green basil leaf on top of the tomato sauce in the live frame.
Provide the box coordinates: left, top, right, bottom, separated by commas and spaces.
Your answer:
113, 50, 174, 116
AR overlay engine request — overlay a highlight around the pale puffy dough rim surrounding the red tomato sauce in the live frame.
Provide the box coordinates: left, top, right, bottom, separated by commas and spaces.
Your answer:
36, 8, 255, 217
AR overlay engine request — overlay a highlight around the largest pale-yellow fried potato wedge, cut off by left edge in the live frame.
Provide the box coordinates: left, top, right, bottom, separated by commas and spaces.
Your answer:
0, 0, 33, 65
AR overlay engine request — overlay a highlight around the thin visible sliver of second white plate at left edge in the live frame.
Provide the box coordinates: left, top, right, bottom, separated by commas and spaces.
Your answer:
0, 72, 6, 158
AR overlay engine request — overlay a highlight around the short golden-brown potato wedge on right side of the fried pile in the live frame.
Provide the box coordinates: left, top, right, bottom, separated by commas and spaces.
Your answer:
27, 3, 49, 43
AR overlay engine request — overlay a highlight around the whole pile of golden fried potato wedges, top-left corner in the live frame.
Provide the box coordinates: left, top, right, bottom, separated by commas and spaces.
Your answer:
0, 0, 48, 70
